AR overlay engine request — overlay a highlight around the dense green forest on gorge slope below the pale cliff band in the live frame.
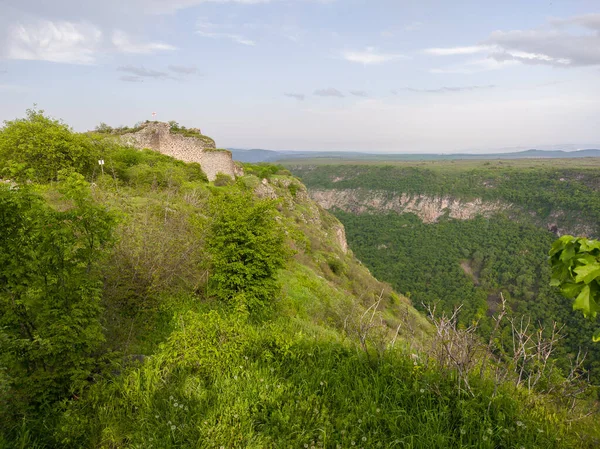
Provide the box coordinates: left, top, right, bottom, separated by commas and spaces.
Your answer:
335, 211, 600, 379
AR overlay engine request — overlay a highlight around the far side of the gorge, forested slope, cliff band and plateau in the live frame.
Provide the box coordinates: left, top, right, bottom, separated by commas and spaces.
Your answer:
291, 159, 600, 383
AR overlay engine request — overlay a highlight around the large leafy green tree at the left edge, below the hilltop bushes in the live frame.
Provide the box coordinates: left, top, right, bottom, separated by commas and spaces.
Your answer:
0, 173, 114, 419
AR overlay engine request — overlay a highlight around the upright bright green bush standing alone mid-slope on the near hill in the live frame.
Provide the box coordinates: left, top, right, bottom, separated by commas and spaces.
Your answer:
207, 189, 288, 310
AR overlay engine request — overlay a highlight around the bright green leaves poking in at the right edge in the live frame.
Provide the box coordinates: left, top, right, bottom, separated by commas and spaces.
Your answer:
550, 235, 600, 342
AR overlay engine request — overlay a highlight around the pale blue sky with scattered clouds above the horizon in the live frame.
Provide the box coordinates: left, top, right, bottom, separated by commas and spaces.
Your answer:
0, 0, 600, 153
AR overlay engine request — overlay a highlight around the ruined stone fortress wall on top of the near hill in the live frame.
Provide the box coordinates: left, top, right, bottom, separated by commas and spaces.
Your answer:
121, 122, 236, 181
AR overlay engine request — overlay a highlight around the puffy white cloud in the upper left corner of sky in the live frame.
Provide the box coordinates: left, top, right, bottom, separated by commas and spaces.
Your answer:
3, 20, 102, 64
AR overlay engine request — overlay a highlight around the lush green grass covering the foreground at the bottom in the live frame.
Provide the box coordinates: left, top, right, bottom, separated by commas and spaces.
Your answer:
45, 304, 592, 449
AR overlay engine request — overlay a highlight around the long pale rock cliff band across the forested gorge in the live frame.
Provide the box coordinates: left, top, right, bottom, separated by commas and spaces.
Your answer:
310, 189, 512, 223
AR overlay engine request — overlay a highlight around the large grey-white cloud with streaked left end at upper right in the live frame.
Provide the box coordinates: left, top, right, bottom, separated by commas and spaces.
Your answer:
424, 13, 600, 68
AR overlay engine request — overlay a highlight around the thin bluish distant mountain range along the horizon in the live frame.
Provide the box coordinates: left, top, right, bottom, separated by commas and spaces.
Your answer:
229, 148, 600, 163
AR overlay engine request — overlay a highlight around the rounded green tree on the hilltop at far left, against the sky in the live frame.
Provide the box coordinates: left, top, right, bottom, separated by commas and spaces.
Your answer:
0, 109, 98, 182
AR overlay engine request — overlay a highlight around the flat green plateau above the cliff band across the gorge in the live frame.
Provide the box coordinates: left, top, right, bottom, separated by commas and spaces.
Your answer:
292, 160, 600, 234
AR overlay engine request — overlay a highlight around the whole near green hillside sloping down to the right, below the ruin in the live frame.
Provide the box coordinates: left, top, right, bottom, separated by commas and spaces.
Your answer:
0, 111, 600, 448
